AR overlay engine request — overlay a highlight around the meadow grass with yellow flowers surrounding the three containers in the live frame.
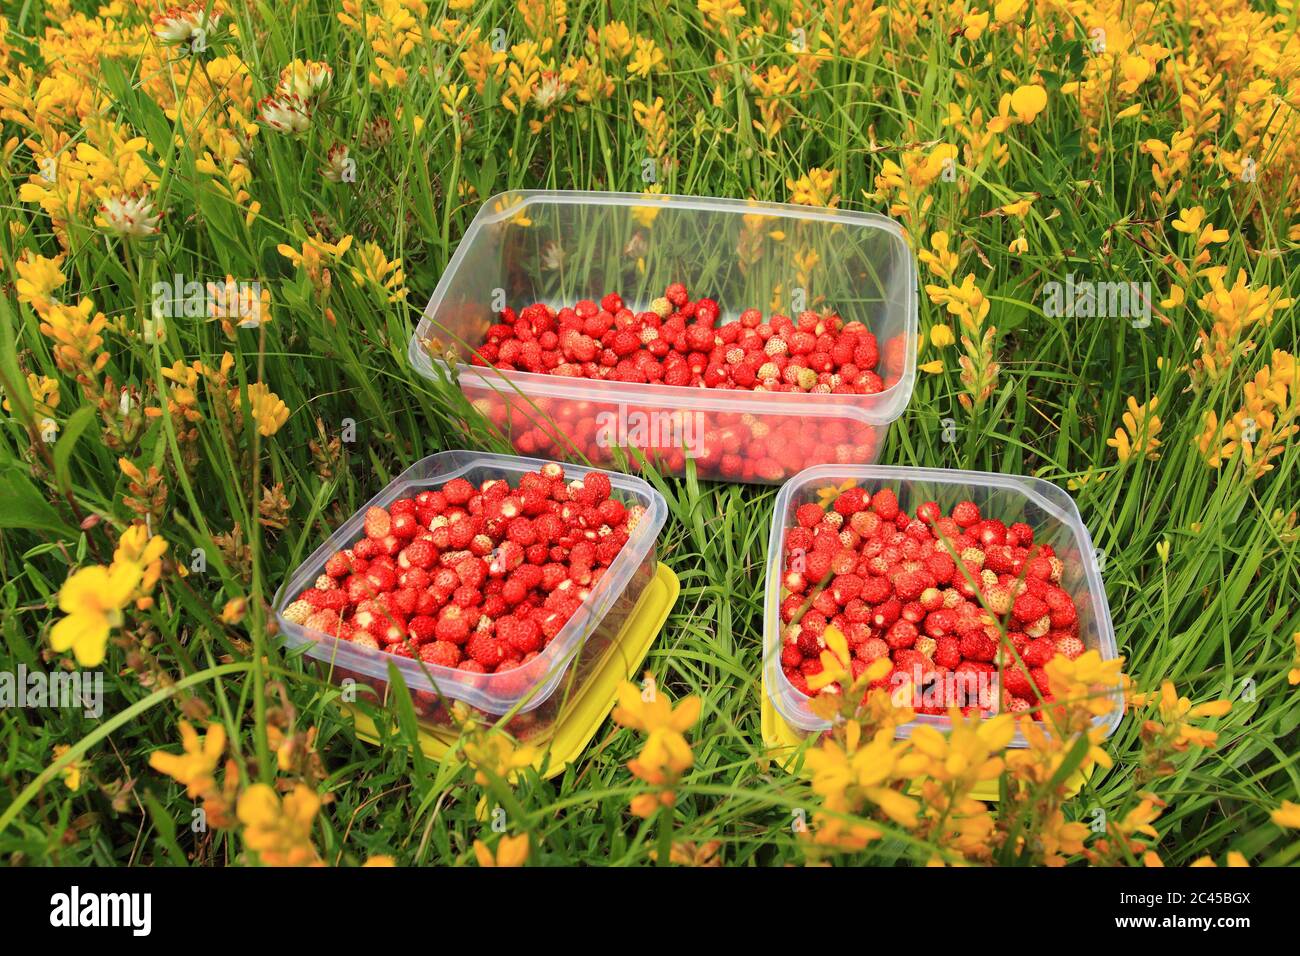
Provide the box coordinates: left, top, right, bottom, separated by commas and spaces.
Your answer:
0, 0, 1300, 865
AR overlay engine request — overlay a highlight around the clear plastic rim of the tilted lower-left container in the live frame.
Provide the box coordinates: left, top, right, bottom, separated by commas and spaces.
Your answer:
274, 449, 668, 715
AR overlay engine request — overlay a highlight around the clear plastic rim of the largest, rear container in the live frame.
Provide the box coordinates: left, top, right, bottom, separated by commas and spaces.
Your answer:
407, 190, 919, 425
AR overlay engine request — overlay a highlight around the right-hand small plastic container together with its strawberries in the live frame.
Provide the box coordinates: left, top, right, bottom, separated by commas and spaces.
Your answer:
763, 466, 1122, 747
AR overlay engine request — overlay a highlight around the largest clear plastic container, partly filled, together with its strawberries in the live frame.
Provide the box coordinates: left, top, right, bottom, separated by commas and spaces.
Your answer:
410, 193, 917, 483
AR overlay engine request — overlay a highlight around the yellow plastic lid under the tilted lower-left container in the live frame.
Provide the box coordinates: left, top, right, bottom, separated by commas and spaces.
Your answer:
348, 562, 686, 777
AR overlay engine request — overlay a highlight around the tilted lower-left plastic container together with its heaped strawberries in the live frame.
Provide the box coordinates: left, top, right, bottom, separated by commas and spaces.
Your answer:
277, 451, 667, 739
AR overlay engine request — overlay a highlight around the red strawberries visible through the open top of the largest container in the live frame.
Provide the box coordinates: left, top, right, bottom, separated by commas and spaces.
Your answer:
473, 282, 885, 395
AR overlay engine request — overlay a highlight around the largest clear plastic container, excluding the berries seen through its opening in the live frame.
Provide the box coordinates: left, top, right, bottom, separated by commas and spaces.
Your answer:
410, 191, 917, 481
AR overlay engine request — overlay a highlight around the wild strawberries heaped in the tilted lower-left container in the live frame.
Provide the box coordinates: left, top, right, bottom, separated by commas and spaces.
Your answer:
282, 463, 645, 674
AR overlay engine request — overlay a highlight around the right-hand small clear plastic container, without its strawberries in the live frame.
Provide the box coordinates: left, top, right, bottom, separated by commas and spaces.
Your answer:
763, 464, 1123, 747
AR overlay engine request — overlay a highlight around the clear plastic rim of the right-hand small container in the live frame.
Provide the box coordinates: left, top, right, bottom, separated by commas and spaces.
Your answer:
763, 464, 1123, 747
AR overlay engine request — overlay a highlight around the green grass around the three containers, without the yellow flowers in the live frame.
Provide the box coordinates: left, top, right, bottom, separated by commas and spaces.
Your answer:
0, 0, 1300, 865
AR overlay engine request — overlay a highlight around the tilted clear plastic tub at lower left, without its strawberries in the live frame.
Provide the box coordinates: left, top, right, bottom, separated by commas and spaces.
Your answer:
276, 451, 668, 739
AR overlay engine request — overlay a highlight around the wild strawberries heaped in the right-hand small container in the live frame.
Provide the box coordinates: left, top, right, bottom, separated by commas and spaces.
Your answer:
780, 488, 1084, 715
